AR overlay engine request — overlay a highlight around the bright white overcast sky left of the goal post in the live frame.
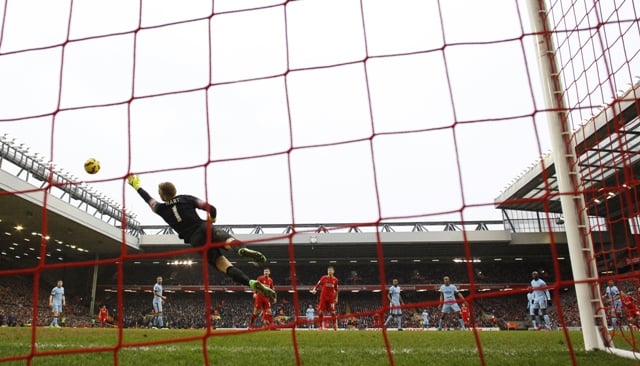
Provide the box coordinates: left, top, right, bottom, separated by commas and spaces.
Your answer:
0, 0, 549, 225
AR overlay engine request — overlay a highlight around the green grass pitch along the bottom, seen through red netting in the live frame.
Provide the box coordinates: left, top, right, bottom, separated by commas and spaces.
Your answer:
0, 328, 640, 366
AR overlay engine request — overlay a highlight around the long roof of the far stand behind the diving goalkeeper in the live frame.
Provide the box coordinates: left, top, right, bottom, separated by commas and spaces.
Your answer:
140, 221, 568, 264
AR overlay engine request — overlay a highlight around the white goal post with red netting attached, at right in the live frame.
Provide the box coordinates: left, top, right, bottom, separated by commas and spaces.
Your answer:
527, 0, 640, 359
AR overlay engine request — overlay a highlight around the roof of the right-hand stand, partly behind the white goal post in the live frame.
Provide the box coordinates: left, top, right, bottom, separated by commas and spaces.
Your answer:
495, 83, 640, 219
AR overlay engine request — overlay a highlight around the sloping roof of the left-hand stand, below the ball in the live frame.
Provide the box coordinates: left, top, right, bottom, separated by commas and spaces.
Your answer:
0, 169, 140, 267
